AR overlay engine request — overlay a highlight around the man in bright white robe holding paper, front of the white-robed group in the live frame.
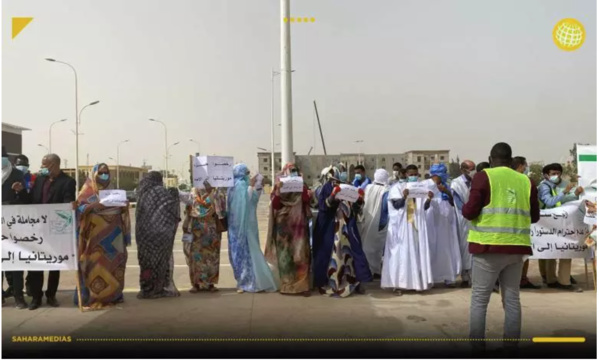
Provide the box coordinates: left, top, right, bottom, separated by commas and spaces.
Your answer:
381, 165, 434, 295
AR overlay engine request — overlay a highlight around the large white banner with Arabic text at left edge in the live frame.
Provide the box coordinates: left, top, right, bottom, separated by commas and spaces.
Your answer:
2, 204, 77, 271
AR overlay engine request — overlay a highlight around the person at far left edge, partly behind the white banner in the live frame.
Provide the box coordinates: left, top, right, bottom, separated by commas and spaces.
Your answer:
2, 147, 27, 309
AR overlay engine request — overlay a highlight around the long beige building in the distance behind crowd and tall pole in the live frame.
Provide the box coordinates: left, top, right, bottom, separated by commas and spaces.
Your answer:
258, 150, 450, 185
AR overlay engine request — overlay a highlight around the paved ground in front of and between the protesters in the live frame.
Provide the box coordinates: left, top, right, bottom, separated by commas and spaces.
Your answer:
2, 197, 597, 358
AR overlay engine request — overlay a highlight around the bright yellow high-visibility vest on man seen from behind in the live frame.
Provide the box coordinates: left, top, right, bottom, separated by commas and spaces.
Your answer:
468, 167, 531, 246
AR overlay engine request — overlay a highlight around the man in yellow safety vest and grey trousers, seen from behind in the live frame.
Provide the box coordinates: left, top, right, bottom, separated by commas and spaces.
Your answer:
462, 143, 540, 352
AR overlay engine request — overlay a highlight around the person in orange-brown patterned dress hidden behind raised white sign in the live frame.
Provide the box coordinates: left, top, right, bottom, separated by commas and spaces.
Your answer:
180, 182, 227, 293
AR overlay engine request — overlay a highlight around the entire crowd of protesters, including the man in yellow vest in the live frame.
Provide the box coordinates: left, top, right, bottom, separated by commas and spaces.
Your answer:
2, 143, 584, 348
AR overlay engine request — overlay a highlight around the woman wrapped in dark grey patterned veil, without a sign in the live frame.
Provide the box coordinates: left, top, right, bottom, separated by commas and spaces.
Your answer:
135, 171, 181, 299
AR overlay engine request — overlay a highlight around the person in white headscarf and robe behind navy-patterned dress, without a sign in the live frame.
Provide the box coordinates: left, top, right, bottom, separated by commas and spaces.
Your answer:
358, 169, 389, 278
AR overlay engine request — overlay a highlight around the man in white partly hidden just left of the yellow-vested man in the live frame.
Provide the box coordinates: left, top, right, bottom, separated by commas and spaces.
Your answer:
451, 160, 476, 288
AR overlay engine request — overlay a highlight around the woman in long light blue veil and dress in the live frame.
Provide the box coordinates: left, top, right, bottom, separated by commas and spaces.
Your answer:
227, 164, 278, 293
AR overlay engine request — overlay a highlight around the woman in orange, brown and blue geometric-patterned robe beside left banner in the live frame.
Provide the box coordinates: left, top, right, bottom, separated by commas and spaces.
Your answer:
74, 163, 131, 309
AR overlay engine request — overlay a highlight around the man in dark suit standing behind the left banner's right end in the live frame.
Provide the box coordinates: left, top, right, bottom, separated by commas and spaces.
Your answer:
21, 154, 76, 310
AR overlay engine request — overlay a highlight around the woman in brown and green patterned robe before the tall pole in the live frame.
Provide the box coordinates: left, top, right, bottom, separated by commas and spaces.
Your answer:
265, 164, 312, 297
